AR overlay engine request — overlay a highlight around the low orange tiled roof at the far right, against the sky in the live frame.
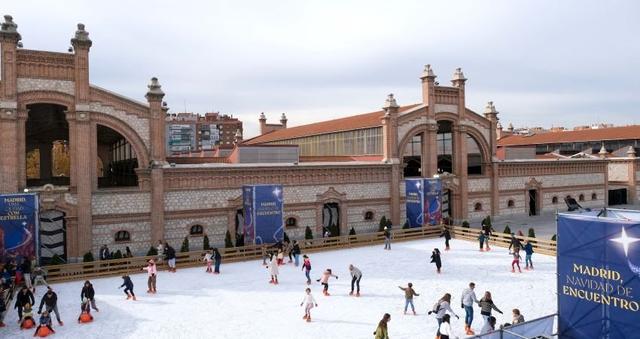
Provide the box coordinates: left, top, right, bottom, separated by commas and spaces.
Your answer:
498, 125, 640, 147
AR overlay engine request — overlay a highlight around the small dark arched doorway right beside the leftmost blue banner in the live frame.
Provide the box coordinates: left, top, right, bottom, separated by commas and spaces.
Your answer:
40, 210, 67, 265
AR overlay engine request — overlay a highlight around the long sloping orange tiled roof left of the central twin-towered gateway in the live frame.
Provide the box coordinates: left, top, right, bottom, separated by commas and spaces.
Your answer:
243, 104, 419, 145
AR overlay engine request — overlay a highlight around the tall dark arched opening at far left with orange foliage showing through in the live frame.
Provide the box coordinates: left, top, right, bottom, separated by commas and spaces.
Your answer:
25, 104, 70, 187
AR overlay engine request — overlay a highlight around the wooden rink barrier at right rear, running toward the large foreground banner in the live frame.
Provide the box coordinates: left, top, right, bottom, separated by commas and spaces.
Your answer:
447, 226, 557, 257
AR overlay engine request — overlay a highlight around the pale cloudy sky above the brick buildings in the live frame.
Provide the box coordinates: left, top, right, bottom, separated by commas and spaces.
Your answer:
0, 0, 640, 138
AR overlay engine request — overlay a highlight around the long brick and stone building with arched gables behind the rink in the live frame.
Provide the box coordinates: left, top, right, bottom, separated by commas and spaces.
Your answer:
0, 16, 640, 261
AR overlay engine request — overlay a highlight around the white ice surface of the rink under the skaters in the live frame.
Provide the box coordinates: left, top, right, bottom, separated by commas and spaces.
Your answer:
0, 239, 556, 339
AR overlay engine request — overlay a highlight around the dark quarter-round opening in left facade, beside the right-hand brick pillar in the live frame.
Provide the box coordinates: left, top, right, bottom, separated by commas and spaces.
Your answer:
96, 124, 138, 188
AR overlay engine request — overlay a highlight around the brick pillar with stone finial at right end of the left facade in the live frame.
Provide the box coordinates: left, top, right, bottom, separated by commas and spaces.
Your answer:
144, 78, 167, 243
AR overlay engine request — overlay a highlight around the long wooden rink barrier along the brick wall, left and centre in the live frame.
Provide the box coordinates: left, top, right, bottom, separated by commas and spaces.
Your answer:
45, 226, 442, 282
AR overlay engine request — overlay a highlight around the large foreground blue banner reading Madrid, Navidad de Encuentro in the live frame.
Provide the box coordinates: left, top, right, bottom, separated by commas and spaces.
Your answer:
557, 214, 640, 339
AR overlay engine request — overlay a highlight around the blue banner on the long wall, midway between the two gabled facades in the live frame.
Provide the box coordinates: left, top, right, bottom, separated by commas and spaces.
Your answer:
242, 185, 284, 245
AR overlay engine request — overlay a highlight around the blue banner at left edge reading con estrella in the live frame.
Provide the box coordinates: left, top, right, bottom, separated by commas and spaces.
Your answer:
0, 193, 38, 262
